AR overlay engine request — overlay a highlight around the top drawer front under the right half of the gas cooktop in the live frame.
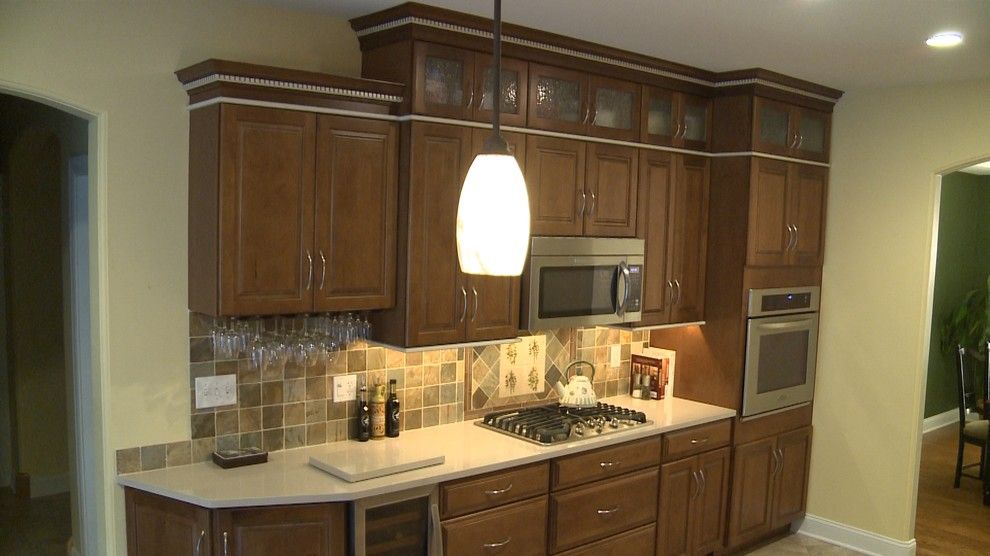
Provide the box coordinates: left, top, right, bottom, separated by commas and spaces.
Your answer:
551, 437, 660, 490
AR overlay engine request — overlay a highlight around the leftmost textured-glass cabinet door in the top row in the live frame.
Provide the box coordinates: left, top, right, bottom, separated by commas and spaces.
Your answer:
413, 42, 478, 120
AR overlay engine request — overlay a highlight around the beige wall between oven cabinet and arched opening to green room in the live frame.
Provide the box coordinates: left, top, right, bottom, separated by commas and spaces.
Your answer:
808, 80, 990, 541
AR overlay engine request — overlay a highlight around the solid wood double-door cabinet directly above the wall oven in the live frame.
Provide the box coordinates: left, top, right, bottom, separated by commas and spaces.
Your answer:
747, 158, 828, 266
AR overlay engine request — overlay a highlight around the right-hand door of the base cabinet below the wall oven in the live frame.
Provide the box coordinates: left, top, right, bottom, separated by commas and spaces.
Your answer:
773, 427, 811, 528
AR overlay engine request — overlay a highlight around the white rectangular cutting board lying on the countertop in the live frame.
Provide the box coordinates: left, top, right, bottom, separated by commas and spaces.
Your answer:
309, 440, 444, 483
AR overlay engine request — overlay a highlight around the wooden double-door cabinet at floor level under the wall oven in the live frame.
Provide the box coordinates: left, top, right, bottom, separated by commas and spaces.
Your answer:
728, 426, 811, 547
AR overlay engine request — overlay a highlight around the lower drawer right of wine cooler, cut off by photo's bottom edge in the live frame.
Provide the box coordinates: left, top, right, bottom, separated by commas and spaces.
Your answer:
443, 495, 547, 556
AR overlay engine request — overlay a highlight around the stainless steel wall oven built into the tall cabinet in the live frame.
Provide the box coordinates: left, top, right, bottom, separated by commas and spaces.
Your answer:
742, 286, 819, 417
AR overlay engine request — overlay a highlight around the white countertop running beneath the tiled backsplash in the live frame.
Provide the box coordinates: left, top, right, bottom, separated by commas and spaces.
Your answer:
117, 396, 736, 508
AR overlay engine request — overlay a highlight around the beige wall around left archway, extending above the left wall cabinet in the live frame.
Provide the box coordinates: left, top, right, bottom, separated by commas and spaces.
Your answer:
0, 1, 360, 553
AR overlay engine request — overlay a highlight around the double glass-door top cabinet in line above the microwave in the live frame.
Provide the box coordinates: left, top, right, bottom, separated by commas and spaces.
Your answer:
527, 63, 640, 141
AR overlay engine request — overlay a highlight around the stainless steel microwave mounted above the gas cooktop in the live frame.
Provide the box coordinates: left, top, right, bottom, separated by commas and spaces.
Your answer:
522, 237, 644, 330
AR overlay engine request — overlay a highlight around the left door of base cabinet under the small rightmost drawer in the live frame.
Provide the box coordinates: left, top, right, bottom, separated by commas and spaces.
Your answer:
657, 458, 701, 556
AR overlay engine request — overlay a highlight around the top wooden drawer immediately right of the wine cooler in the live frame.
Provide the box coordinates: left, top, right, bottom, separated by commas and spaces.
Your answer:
440, 462, 550, 519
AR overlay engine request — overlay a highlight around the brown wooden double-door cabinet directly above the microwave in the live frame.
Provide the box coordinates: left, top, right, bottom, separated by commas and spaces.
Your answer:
526, 135, 639, 237
